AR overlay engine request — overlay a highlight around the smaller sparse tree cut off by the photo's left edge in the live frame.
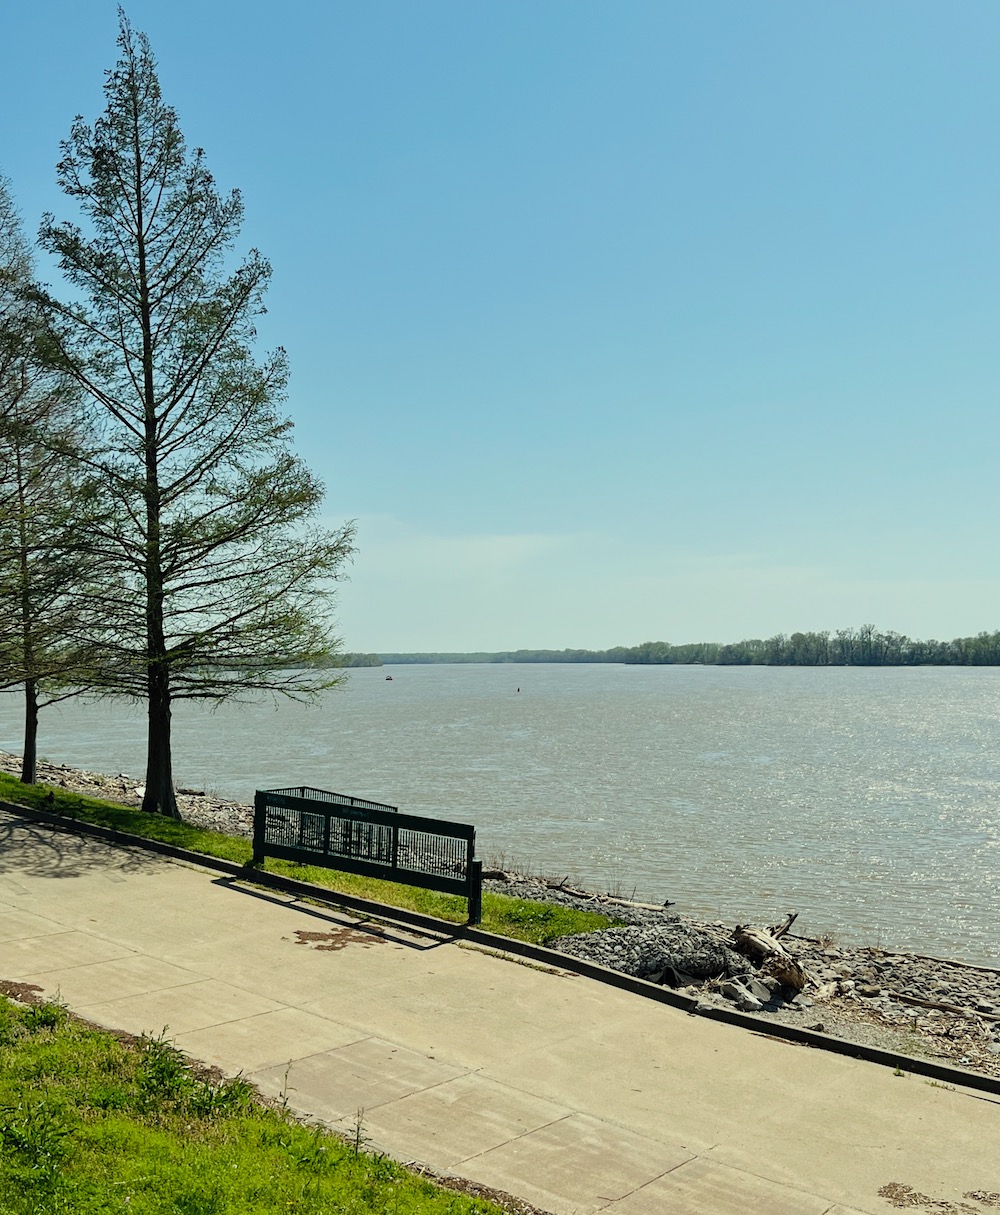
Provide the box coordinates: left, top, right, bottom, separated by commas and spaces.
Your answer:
0, 180, 94, 784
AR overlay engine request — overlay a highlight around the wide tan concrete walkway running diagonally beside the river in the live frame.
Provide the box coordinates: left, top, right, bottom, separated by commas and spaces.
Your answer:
0, 815, 1000, 1215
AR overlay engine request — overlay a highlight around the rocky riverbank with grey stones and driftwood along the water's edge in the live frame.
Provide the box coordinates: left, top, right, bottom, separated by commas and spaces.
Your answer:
7, 752, 1000, 1078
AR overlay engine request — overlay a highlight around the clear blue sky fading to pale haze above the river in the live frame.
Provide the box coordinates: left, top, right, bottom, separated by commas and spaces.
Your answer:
0, 0, 1000, 650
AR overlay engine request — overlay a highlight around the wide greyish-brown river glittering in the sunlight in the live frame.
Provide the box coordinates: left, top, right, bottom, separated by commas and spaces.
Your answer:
0, 665, 1000, 965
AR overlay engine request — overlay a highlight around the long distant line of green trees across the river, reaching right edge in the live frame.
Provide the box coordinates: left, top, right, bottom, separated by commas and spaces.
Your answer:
380, 625, 1000, 667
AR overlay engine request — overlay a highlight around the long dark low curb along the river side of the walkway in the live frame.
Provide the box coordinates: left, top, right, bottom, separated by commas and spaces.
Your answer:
7, 801, 1000, 1097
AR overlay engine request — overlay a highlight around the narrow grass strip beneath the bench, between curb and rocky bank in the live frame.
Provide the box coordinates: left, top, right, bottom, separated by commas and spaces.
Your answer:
0, 773, 621, 945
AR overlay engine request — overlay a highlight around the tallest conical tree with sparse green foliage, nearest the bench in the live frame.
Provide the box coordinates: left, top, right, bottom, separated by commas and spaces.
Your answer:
39, 10, 354, 816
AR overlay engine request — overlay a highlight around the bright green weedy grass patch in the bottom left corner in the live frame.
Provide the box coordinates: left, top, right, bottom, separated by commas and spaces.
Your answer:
0, 999, 501, 1215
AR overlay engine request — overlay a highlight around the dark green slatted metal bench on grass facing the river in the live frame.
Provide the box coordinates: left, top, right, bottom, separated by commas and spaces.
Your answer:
254, 785, 482, 923
